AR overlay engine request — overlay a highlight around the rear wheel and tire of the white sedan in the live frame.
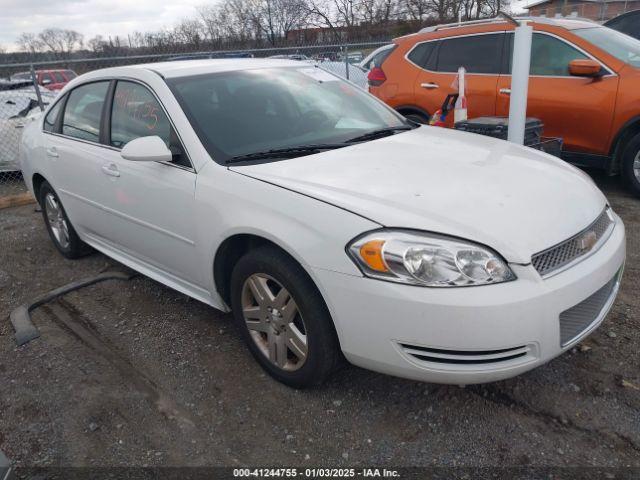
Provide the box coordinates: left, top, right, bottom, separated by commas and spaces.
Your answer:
38, 181, 91, 259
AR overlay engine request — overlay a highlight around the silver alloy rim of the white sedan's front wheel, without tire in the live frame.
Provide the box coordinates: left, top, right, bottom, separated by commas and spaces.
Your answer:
242, 273, 308, 371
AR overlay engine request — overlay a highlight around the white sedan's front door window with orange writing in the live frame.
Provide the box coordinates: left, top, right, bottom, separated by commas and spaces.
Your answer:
110, 81, 191, 167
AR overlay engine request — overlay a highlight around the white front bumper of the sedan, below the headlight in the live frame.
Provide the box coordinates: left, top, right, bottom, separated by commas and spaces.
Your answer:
313, 216, 625, 384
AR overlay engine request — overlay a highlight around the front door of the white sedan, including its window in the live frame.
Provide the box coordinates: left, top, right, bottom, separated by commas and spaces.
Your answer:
91, 80, 204, 290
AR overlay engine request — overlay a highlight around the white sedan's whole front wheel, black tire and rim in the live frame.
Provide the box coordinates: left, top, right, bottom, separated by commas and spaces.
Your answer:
231, 246, 342, 388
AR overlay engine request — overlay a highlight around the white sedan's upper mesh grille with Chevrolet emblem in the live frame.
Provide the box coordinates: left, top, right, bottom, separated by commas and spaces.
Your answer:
531, 207, 613, 277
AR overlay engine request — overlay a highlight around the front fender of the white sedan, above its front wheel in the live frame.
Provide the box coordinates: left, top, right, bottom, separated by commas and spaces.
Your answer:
196, 164, 380, 298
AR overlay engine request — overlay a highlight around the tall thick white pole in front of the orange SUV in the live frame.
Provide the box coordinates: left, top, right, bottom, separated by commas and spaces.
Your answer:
507, 21, 533, 145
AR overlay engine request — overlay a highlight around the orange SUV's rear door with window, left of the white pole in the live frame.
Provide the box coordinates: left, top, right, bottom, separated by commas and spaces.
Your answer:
416, 32, 504, 126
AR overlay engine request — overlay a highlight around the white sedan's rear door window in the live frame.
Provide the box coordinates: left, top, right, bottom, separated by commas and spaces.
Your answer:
62, 82, 109, 143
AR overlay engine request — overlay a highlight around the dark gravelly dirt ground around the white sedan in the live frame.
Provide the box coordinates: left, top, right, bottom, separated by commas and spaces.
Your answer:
0, 171, 640, 467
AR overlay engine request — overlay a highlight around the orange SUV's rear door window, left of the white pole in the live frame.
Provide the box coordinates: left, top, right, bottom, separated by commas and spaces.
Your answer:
436, 34, 503, 74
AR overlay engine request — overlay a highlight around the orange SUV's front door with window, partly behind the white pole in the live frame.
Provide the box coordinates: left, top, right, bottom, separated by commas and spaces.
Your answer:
496, 32, 618, 155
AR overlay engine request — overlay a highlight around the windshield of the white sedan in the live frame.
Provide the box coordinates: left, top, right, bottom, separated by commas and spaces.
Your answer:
167, 66, 407, 163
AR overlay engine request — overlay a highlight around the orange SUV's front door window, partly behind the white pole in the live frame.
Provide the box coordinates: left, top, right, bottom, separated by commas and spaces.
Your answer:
508, 33, 589, 77
